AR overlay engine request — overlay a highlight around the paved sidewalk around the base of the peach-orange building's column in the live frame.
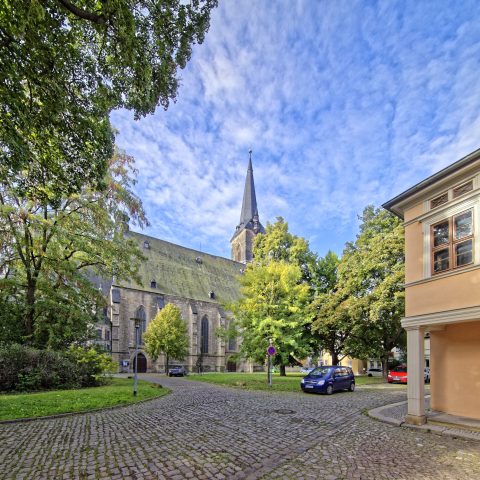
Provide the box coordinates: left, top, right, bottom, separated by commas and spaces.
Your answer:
368, 395, 480, 441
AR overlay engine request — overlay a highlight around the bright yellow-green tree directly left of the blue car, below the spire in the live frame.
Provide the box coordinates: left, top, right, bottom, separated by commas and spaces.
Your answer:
228, 260, 310, 375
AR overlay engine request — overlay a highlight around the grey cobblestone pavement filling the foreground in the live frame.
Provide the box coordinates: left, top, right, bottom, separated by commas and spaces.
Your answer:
0, 378, 480, 480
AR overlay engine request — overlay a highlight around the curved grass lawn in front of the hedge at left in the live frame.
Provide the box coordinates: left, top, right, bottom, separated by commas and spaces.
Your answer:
0, 378, 169, 420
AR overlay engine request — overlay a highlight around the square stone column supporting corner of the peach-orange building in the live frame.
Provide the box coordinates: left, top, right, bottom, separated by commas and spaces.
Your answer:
405, 327, 427, 425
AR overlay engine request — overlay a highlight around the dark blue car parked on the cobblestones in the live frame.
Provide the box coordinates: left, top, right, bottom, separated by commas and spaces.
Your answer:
300, 365, 355, 395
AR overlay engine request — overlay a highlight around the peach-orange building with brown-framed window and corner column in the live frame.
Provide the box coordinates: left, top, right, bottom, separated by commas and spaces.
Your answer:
383, 150, 480, 424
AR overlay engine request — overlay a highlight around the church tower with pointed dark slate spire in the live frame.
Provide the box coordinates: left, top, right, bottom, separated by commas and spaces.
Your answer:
230, 149, 265, 263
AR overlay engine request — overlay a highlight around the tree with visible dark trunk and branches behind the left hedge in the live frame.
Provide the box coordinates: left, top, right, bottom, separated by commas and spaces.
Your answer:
0, 148, 147, 348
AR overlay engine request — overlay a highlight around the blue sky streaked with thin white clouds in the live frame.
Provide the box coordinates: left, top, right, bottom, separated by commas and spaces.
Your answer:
112, 0, 480, 257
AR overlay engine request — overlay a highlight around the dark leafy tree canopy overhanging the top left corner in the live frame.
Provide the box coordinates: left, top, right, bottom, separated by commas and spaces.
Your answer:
0, 0, 217, 199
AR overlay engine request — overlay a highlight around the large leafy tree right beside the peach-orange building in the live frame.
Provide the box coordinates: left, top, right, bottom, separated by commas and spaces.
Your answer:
339, 206, 405, 378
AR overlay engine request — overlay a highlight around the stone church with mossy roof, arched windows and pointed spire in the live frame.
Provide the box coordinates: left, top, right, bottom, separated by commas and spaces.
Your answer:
105, 156, 265, 372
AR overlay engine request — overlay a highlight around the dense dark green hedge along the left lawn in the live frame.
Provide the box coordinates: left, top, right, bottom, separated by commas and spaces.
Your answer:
0, 345, 116, 392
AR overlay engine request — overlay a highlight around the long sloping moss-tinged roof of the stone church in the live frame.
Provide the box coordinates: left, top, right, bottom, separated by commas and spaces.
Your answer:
117, 231, 245, 302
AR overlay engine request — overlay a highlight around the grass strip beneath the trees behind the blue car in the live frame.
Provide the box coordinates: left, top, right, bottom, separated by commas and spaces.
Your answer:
185, 373, 384, 392
